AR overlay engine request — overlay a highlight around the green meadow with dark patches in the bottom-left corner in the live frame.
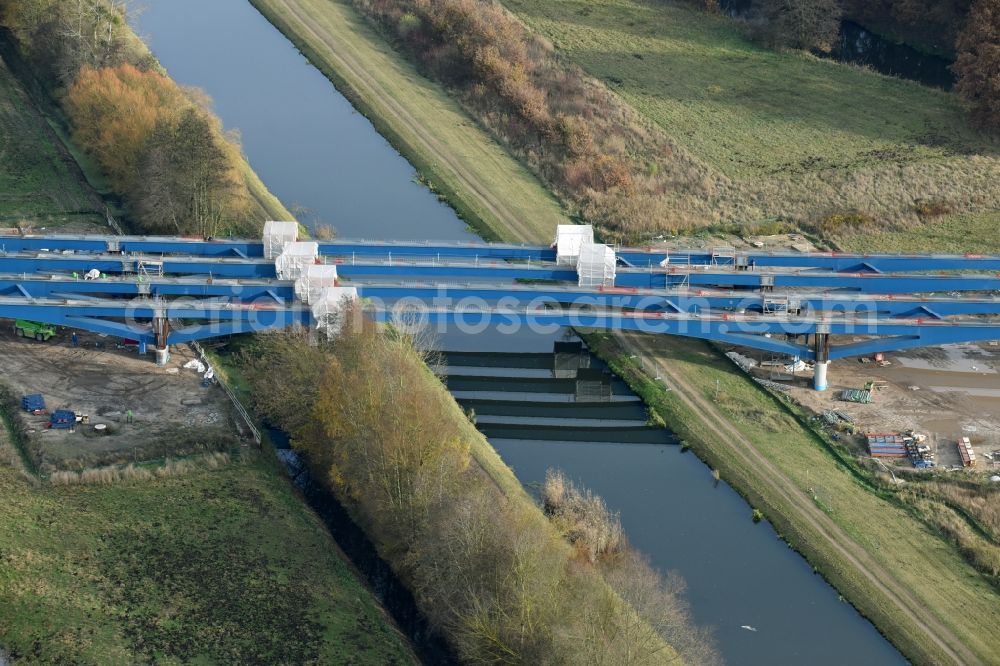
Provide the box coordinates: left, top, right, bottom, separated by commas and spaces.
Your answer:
0, 431, 416, 665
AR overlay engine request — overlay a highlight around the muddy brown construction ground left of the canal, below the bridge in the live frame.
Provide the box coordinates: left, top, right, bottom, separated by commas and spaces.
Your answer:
0, 320, 236, 472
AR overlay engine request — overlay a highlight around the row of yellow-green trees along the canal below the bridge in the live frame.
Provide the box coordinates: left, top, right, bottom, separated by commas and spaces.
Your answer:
244, 320, 716, 665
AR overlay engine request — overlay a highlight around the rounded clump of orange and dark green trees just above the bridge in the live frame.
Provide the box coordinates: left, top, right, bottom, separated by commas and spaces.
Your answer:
63, 63, 251, 236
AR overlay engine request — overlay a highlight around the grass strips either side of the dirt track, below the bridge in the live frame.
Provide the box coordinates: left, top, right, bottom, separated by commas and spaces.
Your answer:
588, 334, 1000, 663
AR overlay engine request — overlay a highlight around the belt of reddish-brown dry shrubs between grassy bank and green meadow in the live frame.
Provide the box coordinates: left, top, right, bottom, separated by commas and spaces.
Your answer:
355, 0, 719, 237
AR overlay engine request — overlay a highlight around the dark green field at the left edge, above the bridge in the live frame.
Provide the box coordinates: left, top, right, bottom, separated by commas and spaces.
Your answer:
0, 55, 104, 228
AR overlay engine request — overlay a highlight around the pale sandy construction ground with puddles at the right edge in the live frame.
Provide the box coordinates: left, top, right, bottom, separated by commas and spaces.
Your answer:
780, 343, 1000, 466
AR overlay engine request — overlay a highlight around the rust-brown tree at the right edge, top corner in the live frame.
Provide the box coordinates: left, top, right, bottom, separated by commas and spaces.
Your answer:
953, 0, 1000, 130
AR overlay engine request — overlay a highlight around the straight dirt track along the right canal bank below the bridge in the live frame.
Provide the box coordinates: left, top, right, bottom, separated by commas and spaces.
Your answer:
615, 332, 982, 664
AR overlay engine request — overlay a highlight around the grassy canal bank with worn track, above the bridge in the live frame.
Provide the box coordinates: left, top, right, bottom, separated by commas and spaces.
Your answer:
251, 0, 570, 242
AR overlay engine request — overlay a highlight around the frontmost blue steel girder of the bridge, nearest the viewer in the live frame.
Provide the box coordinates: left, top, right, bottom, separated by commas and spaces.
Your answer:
0, 290, 1000, 359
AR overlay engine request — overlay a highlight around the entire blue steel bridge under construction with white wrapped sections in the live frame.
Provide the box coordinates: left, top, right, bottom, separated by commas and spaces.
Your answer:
0, 222, 1000, 390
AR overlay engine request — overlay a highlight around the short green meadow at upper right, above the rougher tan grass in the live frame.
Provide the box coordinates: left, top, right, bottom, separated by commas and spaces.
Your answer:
504, 0, 997, 178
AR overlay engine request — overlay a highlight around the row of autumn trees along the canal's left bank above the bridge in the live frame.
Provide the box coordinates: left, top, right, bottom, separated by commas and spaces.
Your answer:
0, 0, 260, 236
